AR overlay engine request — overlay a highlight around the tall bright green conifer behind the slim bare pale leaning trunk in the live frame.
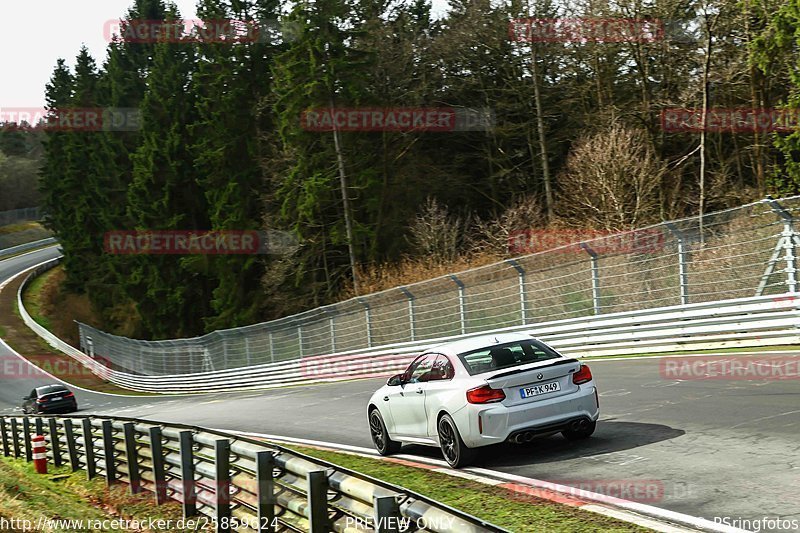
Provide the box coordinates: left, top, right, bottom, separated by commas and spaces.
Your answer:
271, 0, 377, 301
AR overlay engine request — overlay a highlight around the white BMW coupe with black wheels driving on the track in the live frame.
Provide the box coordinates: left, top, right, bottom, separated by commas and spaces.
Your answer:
367, 333, 600, 468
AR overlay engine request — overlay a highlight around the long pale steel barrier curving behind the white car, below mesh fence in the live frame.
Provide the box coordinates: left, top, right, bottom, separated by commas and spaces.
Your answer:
17, 259, 800, 393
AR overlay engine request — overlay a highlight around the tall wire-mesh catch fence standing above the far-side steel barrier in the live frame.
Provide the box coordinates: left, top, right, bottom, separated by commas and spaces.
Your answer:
79, 197, 800, 375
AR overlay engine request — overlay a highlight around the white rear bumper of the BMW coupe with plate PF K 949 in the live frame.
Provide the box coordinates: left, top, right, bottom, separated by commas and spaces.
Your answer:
456, 383, 600, 448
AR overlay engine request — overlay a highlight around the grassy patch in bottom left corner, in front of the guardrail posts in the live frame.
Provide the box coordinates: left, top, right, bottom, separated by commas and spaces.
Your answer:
0, 457, 203, 532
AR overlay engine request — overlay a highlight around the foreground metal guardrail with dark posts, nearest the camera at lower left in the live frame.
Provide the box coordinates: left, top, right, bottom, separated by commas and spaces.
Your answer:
0, 416, 507, 533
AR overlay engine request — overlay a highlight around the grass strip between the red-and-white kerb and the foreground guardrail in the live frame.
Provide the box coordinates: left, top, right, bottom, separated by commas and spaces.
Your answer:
282, 444, 650, 533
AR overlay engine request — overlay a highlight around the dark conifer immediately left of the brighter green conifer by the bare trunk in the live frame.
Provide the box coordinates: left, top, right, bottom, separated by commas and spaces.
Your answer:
192, 0, 278, 330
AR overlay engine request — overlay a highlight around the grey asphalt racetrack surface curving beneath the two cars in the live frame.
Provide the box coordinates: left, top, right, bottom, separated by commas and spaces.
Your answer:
0, 249, 800, 520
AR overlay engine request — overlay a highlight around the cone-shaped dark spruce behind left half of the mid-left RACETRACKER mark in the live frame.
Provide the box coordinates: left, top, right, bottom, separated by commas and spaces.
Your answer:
126, 14, 210, 338
